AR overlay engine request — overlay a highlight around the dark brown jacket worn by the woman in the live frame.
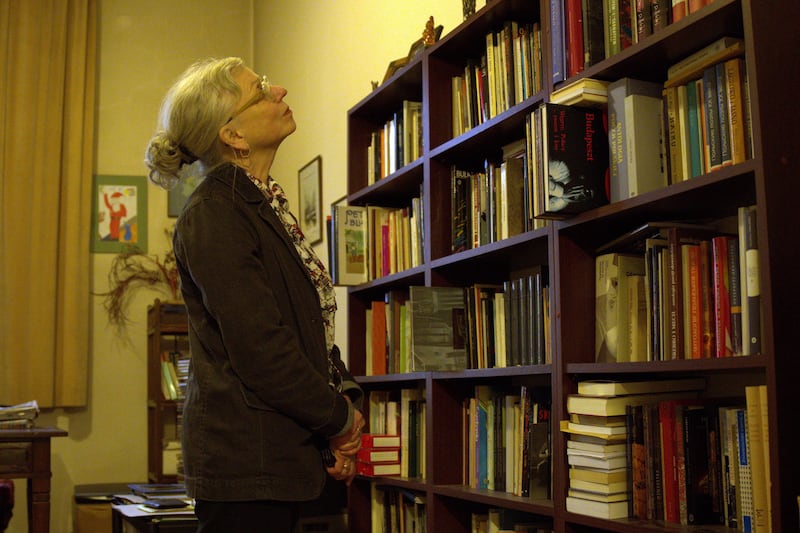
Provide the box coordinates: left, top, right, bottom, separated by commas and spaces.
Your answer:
174, 161, 360, 501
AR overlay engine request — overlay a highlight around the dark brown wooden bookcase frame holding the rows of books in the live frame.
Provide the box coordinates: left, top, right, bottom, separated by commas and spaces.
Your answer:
348, 0, 800, 532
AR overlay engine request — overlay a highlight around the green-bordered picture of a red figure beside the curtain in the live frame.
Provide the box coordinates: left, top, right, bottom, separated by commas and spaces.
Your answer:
92, 172, 147, 253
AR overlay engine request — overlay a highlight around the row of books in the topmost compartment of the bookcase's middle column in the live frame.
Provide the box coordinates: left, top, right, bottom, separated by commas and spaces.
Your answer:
451, 21, 542, 137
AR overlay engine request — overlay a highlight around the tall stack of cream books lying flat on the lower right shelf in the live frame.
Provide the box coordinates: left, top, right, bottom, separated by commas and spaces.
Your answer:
561, 379, 705, 519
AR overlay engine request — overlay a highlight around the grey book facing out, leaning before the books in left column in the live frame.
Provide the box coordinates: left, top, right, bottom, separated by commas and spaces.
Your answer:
408, 286, 468, 372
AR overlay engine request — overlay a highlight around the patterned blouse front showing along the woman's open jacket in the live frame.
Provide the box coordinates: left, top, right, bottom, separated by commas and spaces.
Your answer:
247, 173, 336, 354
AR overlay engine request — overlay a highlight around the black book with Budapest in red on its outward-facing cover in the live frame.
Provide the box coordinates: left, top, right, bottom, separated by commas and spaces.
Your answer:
541, 103, 609, 219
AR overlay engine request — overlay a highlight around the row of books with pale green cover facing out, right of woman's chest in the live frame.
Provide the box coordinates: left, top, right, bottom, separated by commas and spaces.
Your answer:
329, 197, 424, 285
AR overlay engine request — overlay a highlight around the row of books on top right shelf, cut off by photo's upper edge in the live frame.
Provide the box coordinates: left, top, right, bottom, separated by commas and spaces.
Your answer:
550, 0, 712, 83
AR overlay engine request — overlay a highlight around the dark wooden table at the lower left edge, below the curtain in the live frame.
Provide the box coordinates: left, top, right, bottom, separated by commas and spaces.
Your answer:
0, 427, 67, 533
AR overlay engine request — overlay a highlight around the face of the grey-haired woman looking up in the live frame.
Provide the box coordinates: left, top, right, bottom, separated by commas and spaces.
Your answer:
229, 68, 297, 150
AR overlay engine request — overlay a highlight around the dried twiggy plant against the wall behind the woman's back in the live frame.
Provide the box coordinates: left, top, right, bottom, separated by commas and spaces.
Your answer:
99, 229, 179, 329
